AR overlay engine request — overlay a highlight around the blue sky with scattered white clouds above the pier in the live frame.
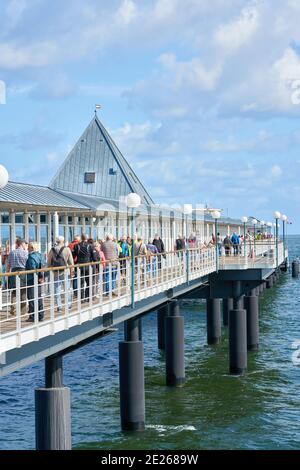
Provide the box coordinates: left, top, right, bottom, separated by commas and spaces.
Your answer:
0, 0, 300, 233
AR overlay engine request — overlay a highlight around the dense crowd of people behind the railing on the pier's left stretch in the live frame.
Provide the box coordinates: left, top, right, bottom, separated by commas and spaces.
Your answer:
4, 234, 166, 322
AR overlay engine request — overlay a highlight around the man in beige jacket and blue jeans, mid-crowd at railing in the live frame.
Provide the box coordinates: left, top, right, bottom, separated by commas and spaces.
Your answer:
102, 234, 119, 295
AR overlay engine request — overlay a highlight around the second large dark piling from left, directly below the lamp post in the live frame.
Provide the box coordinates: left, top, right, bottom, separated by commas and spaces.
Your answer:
119, 318, 145, 431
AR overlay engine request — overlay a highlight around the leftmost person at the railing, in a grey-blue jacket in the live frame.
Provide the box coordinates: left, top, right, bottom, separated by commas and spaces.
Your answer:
6, 239, 28, 315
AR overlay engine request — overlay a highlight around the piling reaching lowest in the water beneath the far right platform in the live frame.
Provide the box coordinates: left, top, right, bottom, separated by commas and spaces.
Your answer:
229, 281, 247, 374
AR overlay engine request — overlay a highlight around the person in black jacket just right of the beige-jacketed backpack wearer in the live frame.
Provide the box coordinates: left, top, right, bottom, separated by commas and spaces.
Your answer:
74, 233, 93, 302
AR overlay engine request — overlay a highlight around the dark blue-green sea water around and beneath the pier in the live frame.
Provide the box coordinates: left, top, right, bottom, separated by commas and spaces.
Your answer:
0, 237, 300, 449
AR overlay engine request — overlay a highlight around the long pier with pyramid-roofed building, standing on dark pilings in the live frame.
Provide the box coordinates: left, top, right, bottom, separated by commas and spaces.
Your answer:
0, 115, 290, 450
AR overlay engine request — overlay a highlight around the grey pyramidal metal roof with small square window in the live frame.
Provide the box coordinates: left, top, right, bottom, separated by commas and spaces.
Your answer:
49, 115, 154, 205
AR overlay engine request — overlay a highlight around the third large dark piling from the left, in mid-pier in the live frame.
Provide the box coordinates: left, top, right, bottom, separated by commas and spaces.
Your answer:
165, 300, 185, 387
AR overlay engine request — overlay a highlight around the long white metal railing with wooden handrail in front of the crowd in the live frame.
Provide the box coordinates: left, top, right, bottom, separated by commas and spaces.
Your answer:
0, 247, 216, 353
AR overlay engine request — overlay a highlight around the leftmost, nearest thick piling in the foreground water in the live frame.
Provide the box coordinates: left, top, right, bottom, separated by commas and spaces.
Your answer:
35, 356, 72, 450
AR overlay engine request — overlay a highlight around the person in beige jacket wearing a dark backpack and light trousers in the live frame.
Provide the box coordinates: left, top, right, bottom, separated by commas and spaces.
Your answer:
48, 236, 74, 312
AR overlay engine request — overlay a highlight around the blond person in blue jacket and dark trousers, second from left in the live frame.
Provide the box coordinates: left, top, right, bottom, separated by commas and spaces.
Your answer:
25, 242, 45, 322
